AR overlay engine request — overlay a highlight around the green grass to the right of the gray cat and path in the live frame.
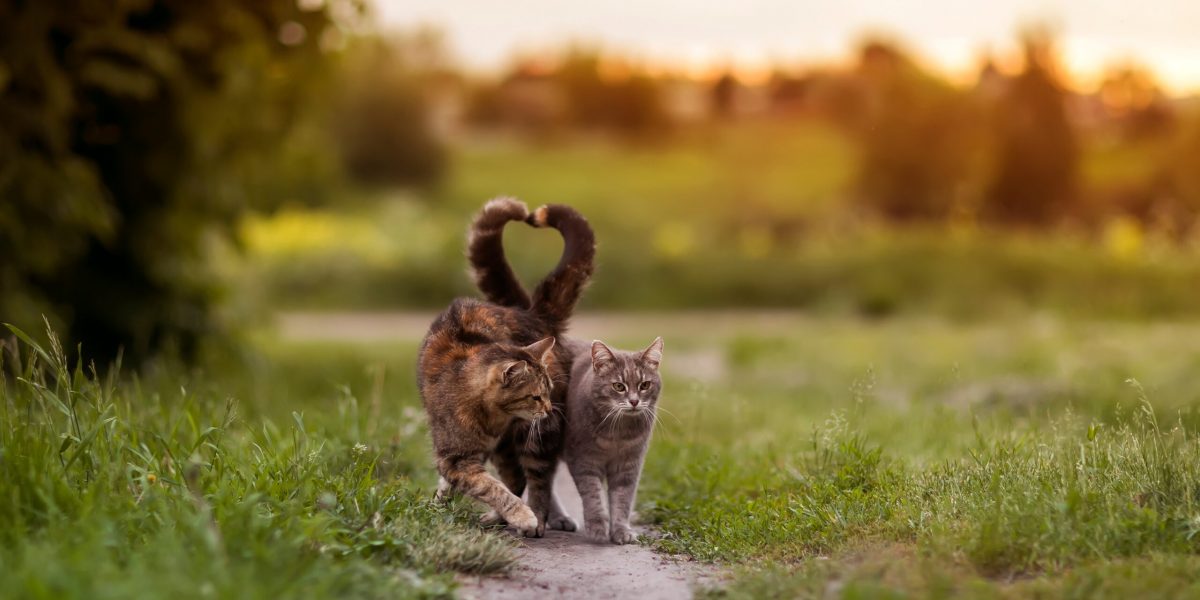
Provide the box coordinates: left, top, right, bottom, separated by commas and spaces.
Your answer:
624, 318, 1200, 598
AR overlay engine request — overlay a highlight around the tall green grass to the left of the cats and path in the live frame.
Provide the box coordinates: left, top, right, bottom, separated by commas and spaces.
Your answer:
0, 331, 514, 598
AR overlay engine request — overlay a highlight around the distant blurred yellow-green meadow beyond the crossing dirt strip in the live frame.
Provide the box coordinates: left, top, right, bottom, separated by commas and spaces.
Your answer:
236, 122, 1200, 319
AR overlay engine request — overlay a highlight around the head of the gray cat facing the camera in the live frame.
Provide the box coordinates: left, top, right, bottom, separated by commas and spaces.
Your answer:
592, 337, 662, 413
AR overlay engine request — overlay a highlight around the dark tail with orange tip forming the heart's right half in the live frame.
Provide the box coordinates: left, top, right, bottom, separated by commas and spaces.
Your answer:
528, 204, 596, 334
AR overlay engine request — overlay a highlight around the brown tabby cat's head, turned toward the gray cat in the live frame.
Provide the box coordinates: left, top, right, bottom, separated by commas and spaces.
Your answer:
490, 337, 554, 421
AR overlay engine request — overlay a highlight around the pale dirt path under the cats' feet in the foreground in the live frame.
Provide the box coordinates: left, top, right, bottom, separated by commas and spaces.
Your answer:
461, 466, 708, 600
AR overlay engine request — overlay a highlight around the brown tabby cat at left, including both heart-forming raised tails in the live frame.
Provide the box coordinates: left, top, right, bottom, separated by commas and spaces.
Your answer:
418, 198, 595, 536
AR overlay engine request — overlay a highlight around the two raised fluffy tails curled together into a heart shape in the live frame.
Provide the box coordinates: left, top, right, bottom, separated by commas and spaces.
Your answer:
467, 198, 596, 332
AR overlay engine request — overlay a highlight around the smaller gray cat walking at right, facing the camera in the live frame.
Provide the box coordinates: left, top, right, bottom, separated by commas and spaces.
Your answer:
563, 337, 662, 544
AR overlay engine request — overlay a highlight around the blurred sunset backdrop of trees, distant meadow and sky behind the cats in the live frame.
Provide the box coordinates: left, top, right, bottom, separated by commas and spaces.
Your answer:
0, 0, 1200, 364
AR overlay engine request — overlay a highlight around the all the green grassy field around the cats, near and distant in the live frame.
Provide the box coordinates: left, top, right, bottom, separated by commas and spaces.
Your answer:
9, 124, 1200, 598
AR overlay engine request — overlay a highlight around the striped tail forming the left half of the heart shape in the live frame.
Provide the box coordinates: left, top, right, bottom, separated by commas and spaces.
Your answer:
467, 198, 530, 308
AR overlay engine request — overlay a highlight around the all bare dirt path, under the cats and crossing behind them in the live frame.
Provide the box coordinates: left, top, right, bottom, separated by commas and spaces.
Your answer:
276, 312, 720, 600
